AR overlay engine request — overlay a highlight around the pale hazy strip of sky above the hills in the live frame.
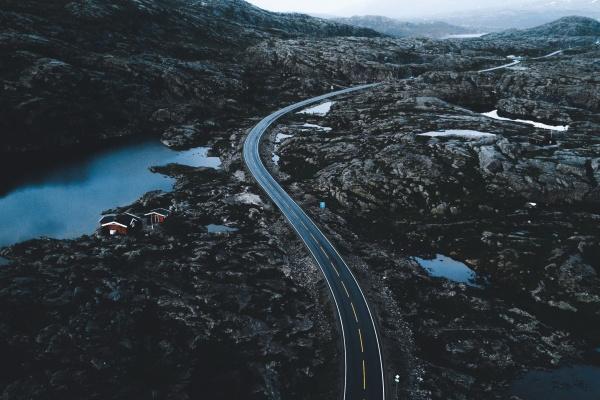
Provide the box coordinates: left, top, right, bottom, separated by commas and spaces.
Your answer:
244, 0, 591, 18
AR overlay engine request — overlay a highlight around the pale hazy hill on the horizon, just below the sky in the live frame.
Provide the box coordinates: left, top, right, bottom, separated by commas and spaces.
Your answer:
334, 15, 472, 38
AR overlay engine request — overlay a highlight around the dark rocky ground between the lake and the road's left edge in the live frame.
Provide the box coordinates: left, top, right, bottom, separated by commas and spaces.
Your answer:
0, 155, 340, 399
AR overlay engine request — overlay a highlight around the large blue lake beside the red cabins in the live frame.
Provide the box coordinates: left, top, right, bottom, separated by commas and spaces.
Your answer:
0, 139, 220, 247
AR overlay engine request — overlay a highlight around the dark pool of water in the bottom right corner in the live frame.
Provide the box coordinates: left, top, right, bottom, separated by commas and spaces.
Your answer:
511, 365, 600, 400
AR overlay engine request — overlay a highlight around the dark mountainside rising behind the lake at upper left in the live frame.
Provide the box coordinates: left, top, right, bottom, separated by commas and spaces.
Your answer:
0, 0, 377, 153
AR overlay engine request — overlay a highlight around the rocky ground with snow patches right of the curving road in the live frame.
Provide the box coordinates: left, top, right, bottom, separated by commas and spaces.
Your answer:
273, 30, 600, 399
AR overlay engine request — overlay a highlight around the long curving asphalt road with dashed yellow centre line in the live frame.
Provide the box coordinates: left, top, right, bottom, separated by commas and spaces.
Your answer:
243, 84, 385, 400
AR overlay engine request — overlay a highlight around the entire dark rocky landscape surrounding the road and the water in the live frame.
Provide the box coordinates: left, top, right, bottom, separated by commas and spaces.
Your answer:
0, 0, 600, 399
